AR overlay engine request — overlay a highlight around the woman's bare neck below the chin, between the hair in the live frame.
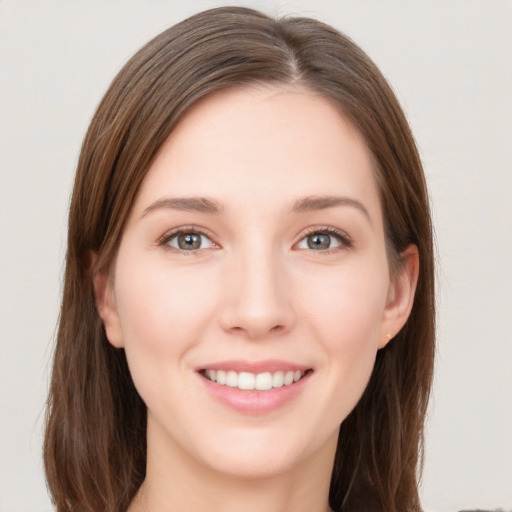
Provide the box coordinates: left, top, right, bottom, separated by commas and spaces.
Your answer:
128, 416, 337, 512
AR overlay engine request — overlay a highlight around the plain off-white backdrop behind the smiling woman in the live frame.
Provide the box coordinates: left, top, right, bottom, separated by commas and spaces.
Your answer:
0, 0, 512, 512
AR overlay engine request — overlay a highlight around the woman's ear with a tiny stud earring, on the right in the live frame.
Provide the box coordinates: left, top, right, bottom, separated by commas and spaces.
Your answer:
379, 244, 420, 348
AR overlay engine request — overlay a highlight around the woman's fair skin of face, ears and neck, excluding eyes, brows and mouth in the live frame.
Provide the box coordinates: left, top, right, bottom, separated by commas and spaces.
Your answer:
95, 86, 418, 512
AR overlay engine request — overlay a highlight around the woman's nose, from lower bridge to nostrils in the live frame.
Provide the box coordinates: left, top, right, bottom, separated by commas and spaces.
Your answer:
221, 247, 296, 340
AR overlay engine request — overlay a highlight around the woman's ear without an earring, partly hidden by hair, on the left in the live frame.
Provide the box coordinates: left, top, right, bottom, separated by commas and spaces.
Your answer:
93, 264, 124, 348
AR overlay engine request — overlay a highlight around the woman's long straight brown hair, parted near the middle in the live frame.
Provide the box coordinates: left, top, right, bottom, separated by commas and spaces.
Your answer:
44, 7, 434, 512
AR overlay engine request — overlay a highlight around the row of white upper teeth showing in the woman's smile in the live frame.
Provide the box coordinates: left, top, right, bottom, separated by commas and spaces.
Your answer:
204, 370, 304, 391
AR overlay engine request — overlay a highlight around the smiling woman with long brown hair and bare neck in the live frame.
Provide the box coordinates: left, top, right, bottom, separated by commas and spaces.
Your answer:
45, 7, 434, 512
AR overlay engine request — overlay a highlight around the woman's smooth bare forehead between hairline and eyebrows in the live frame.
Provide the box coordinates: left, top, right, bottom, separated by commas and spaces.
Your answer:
135, 86, 379, 218
